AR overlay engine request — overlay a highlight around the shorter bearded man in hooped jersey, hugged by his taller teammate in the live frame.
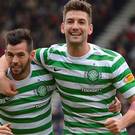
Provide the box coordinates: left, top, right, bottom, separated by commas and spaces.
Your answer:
0, 29, 55, 135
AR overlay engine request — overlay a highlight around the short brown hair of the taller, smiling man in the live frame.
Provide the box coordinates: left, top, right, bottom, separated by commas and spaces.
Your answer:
63, 0, 92, 23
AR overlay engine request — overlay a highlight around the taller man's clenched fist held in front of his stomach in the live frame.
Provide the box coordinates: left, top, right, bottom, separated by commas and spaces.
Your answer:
105, 118, 123, 134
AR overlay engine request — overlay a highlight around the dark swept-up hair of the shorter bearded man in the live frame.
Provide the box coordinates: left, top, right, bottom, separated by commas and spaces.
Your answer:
5, 28, 33, 52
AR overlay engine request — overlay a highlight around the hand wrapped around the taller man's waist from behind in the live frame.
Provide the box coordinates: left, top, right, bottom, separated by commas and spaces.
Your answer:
109, 97, 121, 112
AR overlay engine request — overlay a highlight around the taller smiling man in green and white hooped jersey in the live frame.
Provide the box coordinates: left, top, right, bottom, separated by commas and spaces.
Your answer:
2, 0, 135, 135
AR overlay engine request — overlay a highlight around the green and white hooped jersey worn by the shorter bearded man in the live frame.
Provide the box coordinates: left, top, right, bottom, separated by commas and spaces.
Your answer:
0, 64, 55, 135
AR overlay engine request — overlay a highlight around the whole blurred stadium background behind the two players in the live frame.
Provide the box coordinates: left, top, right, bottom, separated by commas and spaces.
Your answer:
0, 0, 135, 135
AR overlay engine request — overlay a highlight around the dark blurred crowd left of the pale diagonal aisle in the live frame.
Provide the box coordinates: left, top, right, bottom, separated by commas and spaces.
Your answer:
0, 0, 128, 48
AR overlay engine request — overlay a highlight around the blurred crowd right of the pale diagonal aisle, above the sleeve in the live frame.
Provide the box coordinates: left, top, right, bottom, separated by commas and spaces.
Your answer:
110, 15, 135, 74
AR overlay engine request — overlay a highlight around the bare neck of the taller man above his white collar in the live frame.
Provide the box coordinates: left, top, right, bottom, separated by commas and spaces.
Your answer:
67, 43, 90, 57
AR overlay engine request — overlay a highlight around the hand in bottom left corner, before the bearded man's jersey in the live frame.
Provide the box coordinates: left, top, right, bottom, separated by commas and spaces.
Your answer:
0, 124, 13, 135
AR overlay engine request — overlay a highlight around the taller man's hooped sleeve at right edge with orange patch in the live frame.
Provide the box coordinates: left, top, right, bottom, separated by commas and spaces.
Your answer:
111, 55, 135, 98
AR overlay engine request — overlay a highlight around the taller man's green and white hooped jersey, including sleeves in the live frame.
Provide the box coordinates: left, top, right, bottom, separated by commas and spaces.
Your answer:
35, 44, 135, 135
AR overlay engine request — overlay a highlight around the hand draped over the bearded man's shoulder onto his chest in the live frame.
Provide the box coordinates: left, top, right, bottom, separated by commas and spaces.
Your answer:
0, 74, 17, 96
